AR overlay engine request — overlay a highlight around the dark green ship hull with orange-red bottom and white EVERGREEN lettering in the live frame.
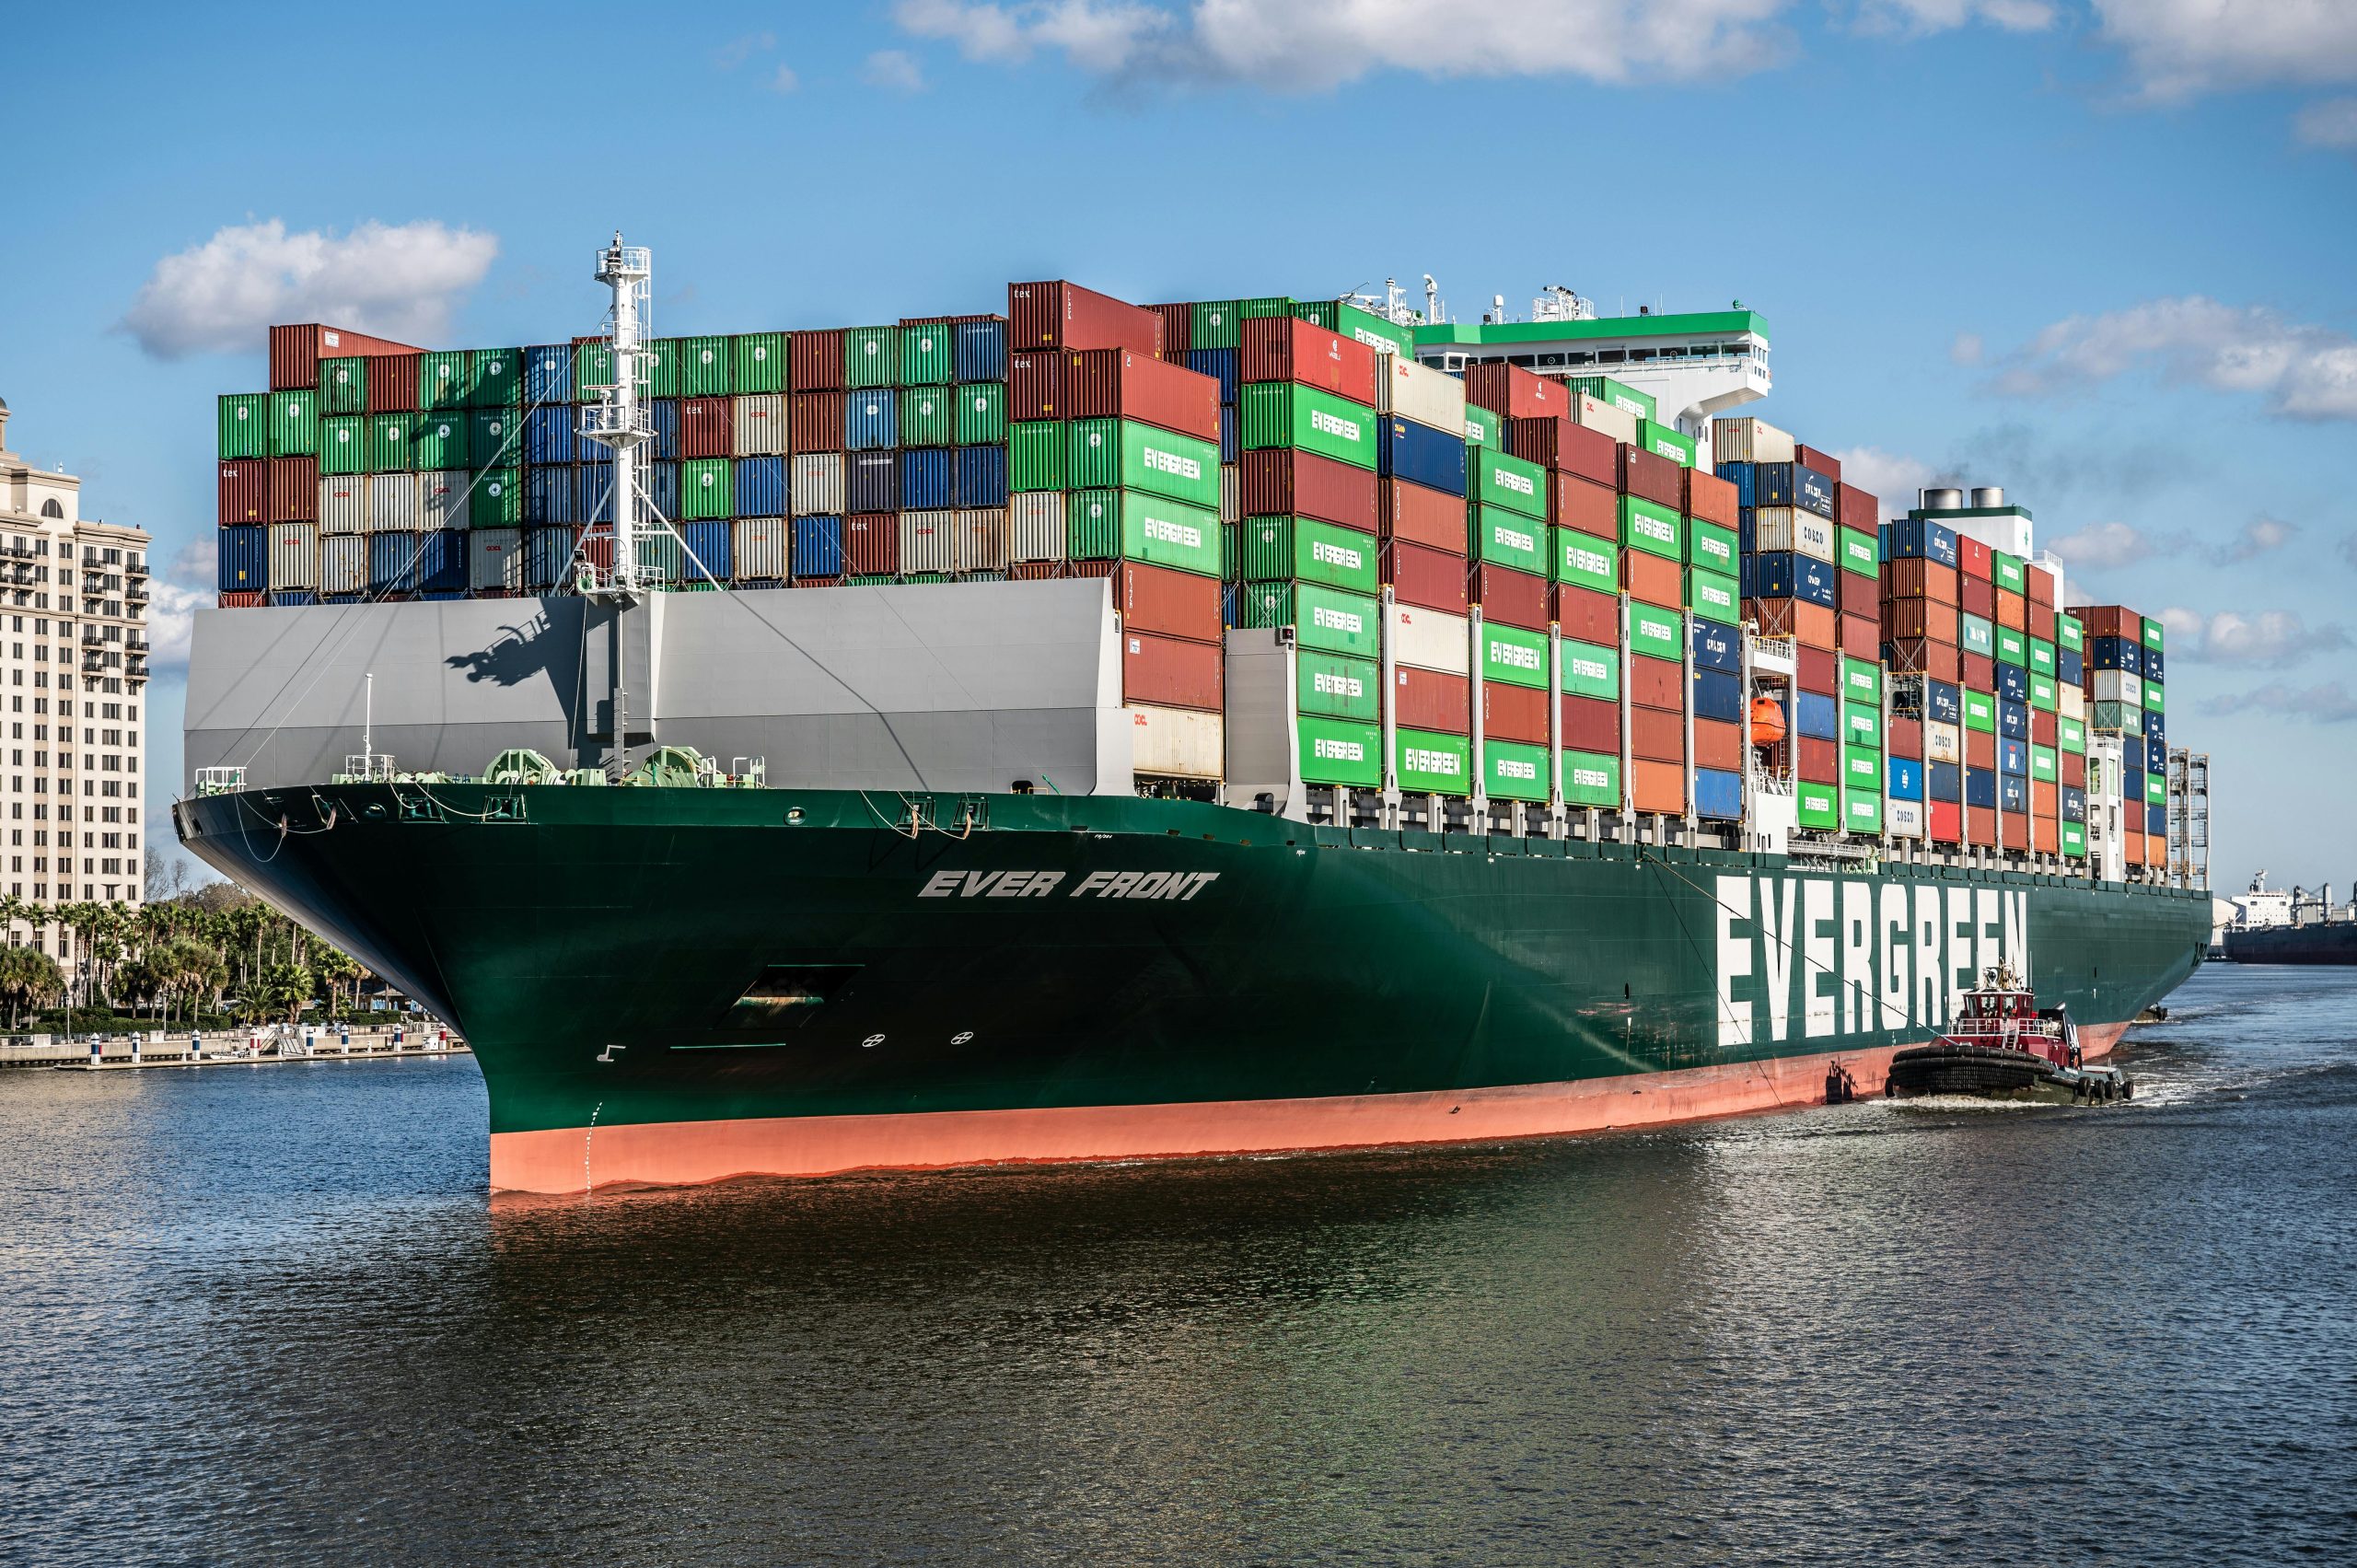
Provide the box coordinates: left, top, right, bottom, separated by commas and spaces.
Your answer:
177, 785, 2209, 1191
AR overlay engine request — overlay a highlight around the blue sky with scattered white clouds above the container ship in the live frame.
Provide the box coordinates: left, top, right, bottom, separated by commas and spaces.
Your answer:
0, 0, 2357, 891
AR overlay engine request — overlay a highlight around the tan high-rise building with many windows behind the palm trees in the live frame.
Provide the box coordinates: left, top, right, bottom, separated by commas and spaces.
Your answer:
0, 401, 148, 970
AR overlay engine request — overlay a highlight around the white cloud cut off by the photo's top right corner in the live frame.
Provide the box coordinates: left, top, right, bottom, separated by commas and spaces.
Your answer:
2096, 0, 2357, 104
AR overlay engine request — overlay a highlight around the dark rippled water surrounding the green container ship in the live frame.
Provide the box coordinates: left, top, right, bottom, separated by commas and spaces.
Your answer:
0, 967, 2357, 1563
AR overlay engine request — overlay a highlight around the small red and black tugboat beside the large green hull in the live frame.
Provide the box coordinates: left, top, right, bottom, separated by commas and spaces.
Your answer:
1883, 964, 2135, 1106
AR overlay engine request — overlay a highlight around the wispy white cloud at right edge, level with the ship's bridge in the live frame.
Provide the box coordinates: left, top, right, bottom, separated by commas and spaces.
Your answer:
1994, 296, 2357, 420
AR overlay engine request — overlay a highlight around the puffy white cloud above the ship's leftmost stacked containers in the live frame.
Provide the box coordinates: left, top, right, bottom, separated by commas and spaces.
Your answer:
121, 217, 500, 358
